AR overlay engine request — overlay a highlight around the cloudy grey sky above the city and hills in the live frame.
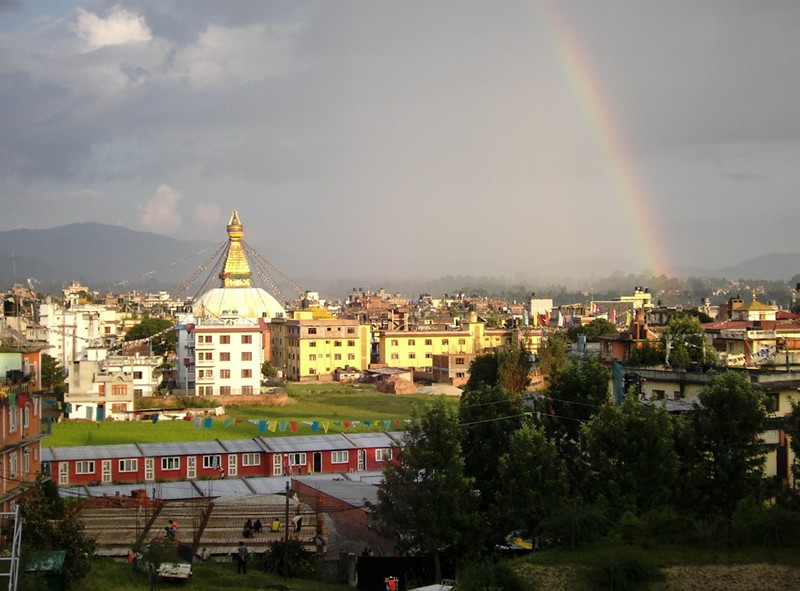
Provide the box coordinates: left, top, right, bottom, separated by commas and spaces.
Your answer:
0, 0, 800, 277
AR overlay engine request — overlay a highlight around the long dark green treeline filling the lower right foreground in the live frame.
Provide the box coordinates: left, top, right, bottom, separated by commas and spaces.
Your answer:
374, 338, 800, 584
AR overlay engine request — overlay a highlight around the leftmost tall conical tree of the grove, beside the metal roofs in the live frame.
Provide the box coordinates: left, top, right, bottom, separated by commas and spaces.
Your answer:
374, 398, 478, 580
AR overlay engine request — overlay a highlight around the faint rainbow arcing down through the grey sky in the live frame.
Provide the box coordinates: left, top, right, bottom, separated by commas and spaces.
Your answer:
536, 2, 670, 275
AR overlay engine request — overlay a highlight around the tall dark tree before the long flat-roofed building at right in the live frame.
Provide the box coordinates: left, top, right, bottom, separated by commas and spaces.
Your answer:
691, 372, 767, 518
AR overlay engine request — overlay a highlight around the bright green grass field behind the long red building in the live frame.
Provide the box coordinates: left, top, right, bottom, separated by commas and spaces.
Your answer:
42, 384, 458, 447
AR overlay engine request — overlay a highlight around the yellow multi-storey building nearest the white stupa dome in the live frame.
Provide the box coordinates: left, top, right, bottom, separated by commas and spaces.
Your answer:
270, 308, 371, 381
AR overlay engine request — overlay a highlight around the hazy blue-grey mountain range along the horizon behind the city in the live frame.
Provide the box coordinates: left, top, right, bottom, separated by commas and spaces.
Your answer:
0, 222, 800, 296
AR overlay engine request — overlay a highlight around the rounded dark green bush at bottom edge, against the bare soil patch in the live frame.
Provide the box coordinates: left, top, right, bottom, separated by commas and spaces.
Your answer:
583, 546, 665, 591
